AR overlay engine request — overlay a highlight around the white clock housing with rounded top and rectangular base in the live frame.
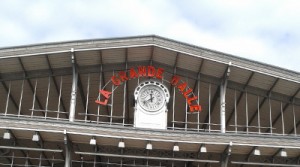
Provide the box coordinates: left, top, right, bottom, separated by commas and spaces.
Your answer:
134, 80, 170, 129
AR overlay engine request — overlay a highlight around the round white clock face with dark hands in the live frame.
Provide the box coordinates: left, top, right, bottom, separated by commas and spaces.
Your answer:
138, 85, 165, 112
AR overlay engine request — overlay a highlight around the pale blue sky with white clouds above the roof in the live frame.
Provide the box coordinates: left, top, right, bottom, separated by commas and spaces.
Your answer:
0, 0, 300, 72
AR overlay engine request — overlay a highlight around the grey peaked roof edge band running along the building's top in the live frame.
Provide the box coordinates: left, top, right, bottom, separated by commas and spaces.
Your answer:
0, 35, 300, 83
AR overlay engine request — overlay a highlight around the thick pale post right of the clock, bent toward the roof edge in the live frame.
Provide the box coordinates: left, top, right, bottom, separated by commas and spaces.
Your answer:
220, 62, 231, 133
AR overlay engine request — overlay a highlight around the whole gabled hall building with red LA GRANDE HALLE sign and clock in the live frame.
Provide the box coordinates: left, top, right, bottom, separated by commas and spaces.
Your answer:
0, 36, 300, 167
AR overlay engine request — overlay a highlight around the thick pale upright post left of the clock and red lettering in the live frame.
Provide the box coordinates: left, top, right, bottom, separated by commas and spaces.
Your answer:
69, 48, 78, 122
